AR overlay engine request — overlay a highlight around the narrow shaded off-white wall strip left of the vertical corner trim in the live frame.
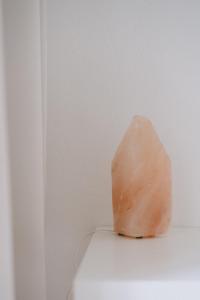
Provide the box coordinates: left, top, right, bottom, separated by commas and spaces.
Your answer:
1, 0, 45, 300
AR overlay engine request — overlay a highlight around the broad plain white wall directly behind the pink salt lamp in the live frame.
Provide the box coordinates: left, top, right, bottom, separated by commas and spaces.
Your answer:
46, 0, 200, 300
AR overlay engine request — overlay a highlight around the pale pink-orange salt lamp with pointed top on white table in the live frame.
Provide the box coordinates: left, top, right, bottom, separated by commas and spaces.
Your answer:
112, 116, 171, 237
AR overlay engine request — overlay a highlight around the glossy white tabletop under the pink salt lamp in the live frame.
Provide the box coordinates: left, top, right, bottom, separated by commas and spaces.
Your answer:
71, 228, 200, 300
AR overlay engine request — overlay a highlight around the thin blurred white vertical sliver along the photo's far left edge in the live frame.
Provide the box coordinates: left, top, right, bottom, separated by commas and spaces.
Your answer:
0, 0, 15, 300
